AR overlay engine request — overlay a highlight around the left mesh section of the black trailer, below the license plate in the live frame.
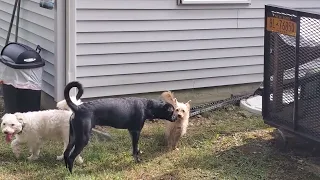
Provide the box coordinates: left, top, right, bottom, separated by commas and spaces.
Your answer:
269, 11, 296, 126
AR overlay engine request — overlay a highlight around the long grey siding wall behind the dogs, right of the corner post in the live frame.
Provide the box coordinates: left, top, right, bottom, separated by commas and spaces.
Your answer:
76, 0, 320, 98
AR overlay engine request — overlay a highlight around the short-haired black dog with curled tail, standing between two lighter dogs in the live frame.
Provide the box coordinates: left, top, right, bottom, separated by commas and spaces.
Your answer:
64, 81, 177, 173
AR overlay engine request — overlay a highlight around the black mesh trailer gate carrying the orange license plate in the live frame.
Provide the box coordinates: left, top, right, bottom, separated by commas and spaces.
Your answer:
263, 6, 320, 142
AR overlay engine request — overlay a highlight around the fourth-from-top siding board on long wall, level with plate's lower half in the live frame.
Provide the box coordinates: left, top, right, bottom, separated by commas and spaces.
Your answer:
77, 28, 264, 44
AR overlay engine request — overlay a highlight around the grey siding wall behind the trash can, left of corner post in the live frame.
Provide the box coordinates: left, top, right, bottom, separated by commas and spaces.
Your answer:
0, 0, 55, 97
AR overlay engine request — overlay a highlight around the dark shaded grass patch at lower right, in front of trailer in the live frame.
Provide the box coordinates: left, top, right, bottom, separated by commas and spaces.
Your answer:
176, 129, 319, 180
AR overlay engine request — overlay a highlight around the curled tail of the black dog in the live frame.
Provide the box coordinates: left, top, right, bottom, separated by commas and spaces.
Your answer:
64, 81, 83, 112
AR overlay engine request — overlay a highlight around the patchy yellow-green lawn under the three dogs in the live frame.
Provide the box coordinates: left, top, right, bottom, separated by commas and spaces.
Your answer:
0, 108, 319, 180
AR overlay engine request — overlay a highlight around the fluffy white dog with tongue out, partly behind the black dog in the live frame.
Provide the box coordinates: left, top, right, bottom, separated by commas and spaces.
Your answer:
1, 100, 83, 163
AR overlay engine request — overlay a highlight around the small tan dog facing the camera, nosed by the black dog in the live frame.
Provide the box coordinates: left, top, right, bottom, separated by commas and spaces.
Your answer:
162, 91, 191, 150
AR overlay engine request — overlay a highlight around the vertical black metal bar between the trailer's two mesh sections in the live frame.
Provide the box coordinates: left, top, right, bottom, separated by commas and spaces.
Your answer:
293, 12, 300, 131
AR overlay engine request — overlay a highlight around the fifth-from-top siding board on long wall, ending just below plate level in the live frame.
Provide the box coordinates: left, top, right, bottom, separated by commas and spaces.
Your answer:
77, 37, 263, 55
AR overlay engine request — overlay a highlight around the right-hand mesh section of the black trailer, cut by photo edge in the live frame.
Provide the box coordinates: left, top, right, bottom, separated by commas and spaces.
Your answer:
298, 17, 320, 138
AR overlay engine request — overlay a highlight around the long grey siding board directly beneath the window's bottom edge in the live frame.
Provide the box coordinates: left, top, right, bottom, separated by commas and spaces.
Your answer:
77, 7, 319, 21
